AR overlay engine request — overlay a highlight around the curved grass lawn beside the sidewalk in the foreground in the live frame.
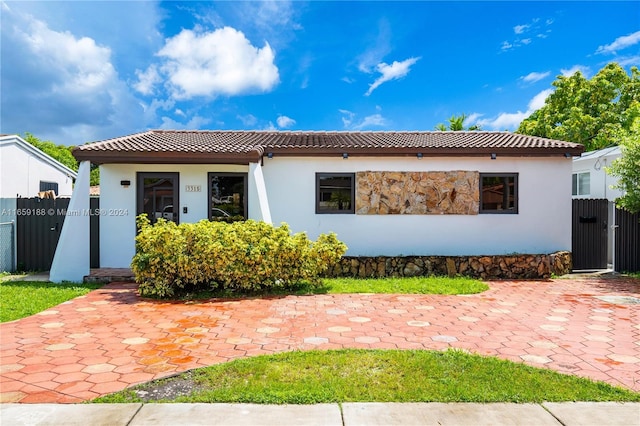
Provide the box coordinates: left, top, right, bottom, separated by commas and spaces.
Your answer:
93, 349, 640, 404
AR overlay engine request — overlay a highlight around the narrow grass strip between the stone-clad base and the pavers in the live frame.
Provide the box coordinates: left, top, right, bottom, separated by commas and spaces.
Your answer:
179, 276, 489, 300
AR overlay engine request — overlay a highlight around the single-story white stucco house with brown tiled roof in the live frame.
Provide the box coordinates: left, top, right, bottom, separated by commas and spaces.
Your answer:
52, 130, 583, 279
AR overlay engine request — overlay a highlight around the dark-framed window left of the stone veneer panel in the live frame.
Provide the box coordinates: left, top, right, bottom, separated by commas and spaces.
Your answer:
316, 173, 355, 214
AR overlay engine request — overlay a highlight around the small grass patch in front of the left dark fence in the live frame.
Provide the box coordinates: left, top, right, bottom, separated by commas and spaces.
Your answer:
0, 276, 102, 322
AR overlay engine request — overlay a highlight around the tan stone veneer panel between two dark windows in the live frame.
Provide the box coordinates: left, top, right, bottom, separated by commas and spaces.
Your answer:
356, 170, 480, 215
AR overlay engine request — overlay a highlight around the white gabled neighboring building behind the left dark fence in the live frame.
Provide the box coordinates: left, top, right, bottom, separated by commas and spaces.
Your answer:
0, 135, 76, 198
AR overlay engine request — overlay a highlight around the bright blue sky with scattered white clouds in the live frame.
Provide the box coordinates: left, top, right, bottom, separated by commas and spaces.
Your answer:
0, 1, 640, 145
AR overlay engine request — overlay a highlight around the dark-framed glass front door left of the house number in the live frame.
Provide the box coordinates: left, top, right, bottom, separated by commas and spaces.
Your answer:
137, 173, 180, 223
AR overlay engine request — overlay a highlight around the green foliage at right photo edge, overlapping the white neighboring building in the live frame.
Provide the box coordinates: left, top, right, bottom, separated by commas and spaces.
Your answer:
606, 118, 640, 213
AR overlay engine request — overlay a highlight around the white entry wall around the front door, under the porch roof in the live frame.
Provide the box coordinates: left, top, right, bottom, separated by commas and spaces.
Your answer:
100, 164, 248, 268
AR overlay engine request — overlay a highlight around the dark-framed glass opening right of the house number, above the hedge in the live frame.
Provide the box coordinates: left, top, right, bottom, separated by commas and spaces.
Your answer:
209, 173, 247, 219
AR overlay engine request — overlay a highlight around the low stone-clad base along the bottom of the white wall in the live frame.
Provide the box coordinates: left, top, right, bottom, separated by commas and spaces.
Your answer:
326, 251, 572, 279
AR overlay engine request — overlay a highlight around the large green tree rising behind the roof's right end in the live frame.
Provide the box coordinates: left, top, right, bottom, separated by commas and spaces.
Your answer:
516, 63, 640, 151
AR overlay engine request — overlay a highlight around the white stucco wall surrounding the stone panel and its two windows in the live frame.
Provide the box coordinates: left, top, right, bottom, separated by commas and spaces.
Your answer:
263, 156, 571, 256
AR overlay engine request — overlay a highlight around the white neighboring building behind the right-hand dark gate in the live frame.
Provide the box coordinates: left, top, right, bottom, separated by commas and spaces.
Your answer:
571, 146, 622, 201
